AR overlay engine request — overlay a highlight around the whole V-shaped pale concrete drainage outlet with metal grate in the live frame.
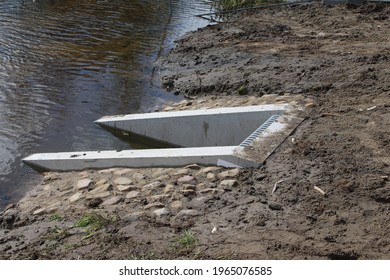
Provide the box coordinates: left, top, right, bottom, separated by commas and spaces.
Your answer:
23, 104, 302, 171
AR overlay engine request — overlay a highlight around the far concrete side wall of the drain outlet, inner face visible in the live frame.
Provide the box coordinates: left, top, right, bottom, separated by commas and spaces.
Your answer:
96, 105, 287, 147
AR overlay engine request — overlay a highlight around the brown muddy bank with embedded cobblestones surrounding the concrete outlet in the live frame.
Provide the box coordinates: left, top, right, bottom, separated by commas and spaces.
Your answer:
0, 5, 390, 259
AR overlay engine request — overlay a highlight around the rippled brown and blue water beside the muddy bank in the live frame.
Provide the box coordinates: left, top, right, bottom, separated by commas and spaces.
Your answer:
0, 0, 210, 208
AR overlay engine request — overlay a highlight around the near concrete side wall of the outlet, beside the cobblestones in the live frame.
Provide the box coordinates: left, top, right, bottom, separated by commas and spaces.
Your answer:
23, 146, 259, 171
